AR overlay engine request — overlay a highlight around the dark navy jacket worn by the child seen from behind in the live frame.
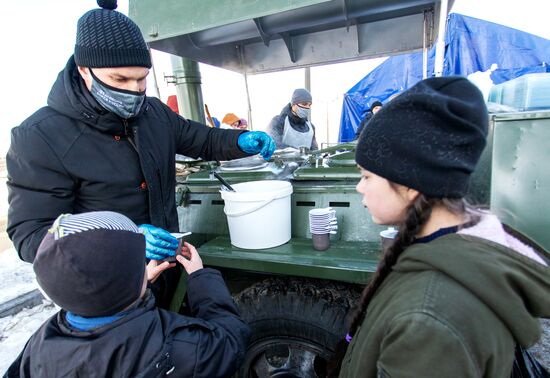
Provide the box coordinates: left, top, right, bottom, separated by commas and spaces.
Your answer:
5, 269, 250, 378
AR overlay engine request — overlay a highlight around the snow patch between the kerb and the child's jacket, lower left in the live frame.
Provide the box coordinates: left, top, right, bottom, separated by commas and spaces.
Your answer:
0, 300, 59, 374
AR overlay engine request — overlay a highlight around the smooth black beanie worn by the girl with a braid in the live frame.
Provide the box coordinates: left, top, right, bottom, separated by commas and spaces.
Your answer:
355, 76, 488, 198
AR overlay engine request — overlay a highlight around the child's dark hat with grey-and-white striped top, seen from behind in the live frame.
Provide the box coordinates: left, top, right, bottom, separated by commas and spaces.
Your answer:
33, 211, 145, 317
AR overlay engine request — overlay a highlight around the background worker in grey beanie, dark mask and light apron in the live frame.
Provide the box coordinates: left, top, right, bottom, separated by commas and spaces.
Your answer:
266, 88, 318, 150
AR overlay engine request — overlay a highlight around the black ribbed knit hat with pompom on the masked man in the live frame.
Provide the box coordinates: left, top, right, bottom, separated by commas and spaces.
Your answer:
74, 0, 151, 68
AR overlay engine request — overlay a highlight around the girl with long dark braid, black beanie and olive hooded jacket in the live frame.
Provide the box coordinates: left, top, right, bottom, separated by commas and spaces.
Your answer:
330, 77, 550, 378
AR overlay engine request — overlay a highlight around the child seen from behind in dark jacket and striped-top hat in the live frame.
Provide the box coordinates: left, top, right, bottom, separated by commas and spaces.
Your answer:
6, 211, 250, 378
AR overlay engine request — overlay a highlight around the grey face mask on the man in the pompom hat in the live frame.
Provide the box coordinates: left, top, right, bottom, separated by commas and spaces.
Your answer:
90, 69, 145, 119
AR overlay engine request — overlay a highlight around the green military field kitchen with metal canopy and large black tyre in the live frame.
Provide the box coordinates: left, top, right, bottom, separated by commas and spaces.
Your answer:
130, 0, 550, 377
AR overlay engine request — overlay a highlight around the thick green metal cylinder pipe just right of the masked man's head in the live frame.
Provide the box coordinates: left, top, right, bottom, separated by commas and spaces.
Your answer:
170, 55, 205, 123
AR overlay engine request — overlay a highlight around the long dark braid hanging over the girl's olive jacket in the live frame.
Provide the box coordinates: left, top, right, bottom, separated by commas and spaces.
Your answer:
327, 193, 479, 377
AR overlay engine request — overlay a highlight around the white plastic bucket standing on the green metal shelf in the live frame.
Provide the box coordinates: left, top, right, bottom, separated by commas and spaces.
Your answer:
220, 180, 292, 249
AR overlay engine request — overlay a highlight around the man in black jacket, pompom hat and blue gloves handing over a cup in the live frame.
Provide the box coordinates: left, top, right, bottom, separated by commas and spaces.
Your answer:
6, 0, 275, 306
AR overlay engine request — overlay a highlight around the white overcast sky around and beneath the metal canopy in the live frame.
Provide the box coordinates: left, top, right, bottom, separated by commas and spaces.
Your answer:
0, 0, 550, 154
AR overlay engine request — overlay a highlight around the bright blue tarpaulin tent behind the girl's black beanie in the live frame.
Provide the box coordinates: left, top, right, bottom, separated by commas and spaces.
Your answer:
338, 13, 550, 142
